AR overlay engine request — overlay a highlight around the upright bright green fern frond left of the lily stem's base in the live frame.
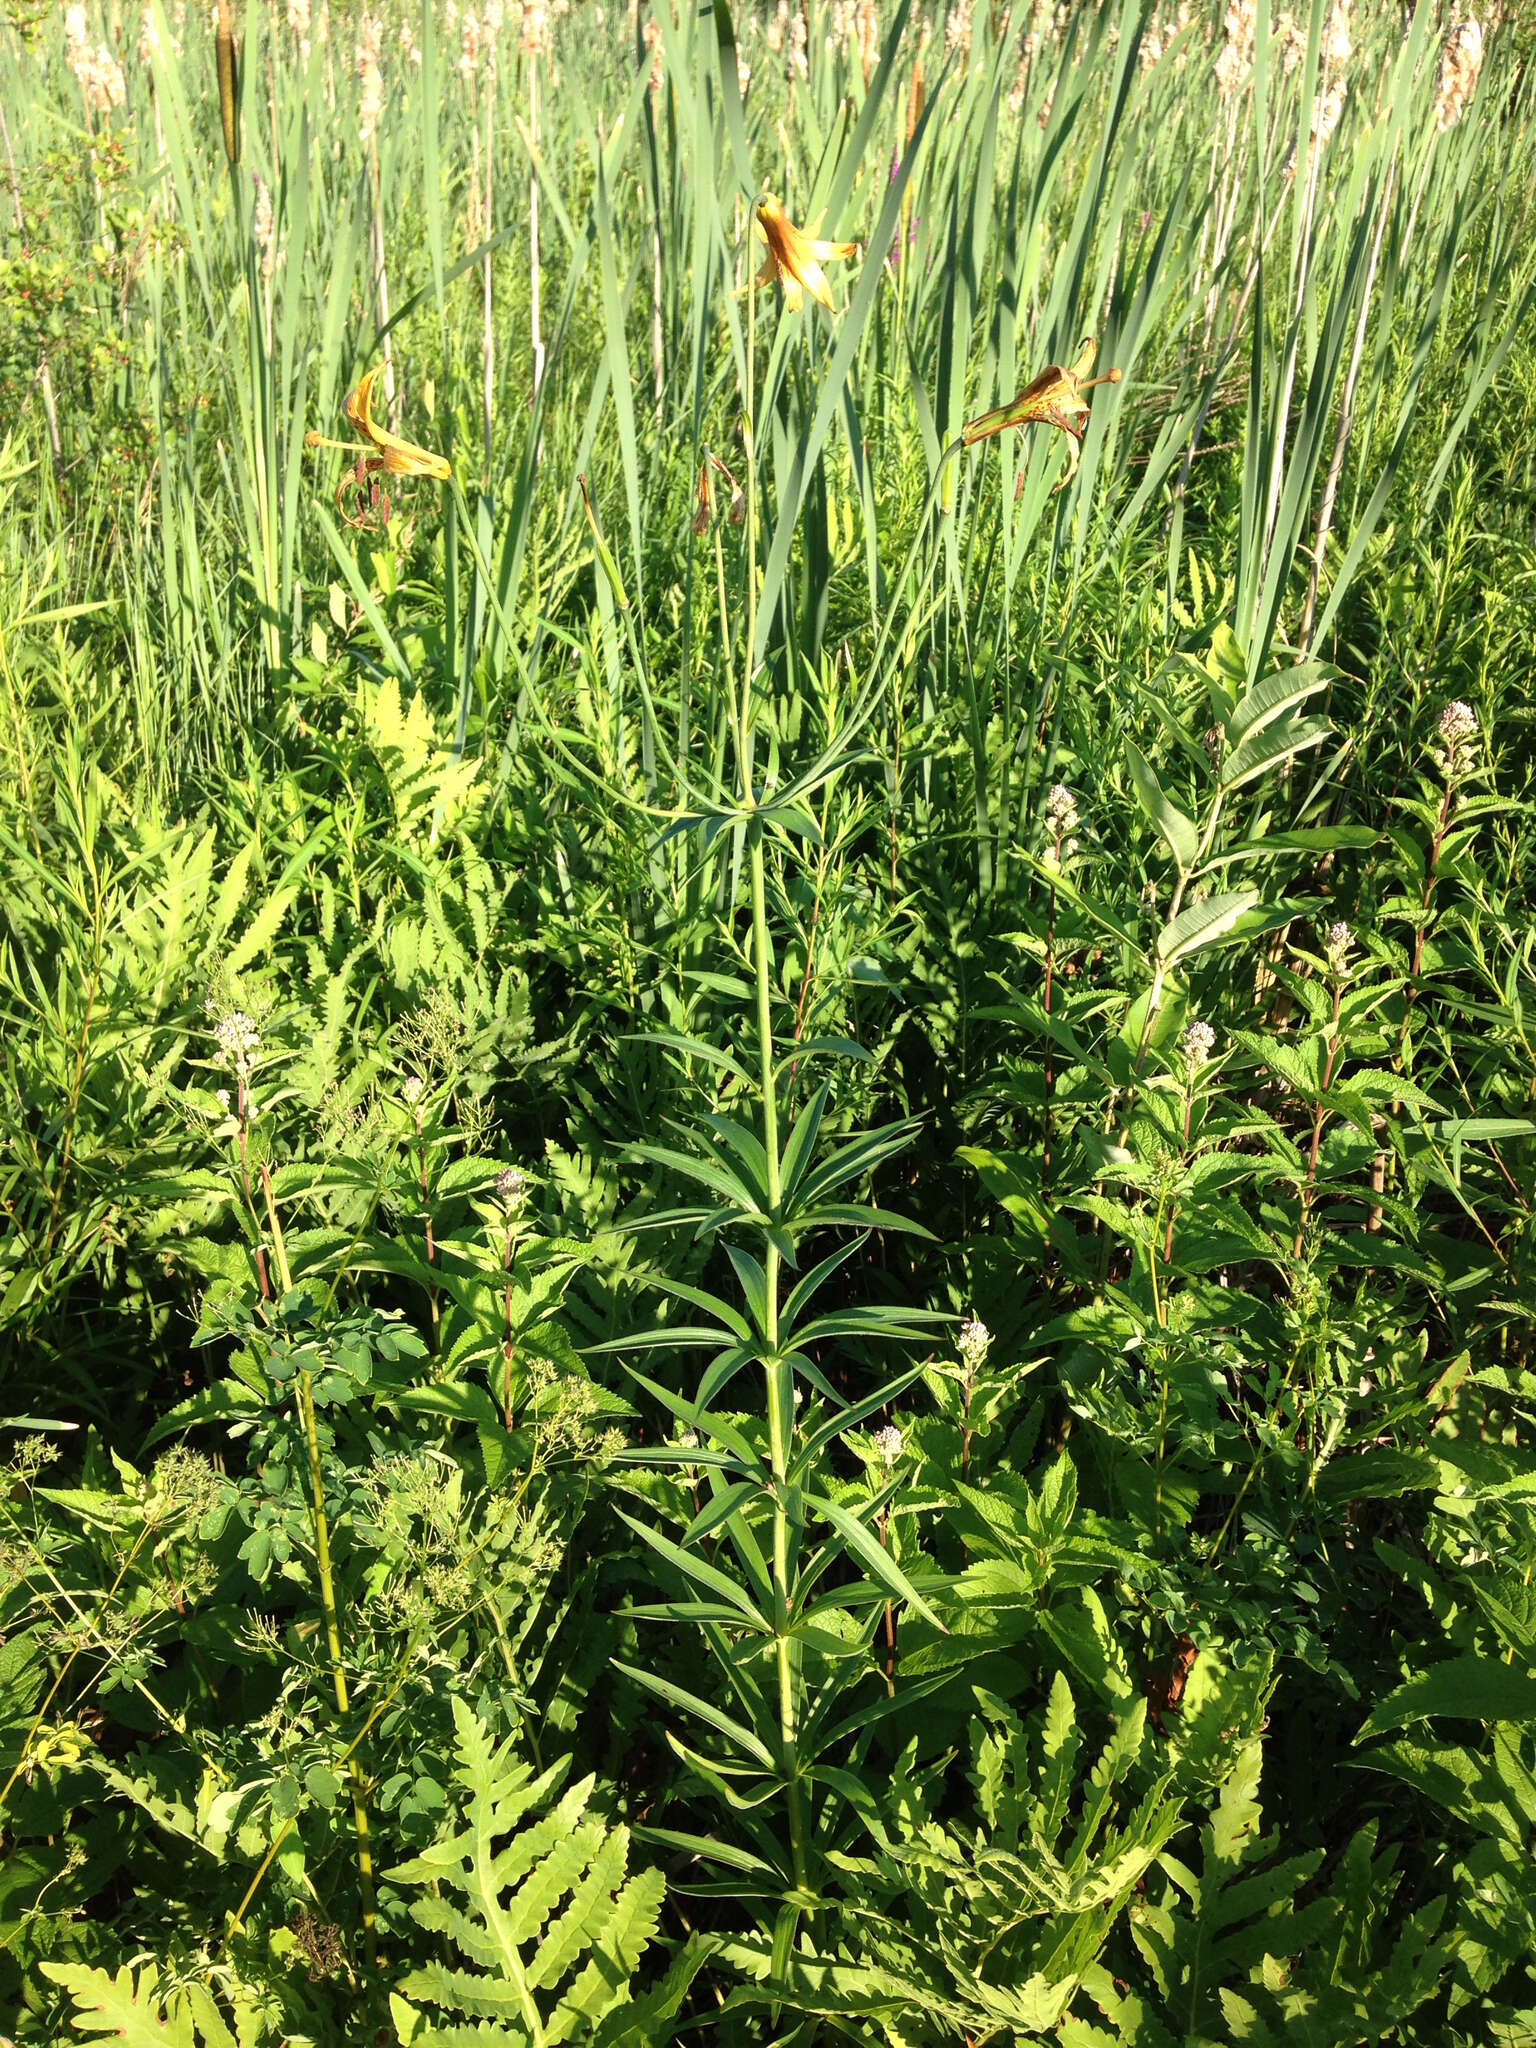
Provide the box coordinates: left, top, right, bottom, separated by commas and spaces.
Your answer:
391, 1700, 702, 2048
